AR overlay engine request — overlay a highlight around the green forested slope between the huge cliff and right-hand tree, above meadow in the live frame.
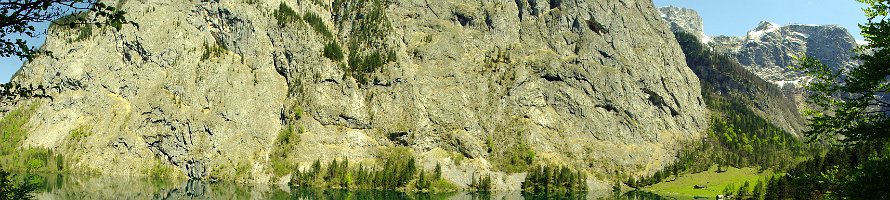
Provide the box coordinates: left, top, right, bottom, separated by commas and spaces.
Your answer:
660, 29, 825, 191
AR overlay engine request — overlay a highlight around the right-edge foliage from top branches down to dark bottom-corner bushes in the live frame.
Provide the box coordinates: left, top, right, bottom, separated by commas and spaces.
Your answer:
766, 0, 890, 199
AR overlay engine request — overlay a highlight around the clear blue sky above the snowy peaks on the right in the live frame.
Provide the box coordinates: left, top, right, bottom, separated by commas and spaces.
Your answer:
653, 0, 867, 40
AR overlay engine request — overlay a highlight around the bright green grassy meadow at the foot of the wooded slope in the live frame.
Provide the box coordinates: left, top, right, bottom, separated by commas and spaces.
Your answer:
643, 165, 773, 199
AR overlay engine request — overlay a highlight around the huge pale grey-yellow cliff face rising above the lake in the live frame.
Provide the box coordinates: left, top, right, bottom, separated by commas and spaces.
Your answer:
3, 0, 708, 189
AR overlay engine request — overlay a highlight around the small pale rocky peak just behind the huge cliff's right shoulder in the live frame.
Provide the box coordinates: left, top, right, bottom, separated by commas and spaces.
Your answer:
658, 6, 711, 44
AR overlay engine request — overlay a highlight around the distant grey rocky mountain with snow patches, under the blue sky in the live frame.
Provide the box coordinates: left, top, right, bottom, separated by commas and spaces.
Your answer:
712, 22, 858, 87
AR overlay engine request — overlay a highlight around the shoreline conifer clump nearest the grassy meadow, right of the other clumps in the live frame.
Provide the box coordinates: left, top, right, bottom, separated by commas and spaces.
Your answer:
522, 165, 587, 193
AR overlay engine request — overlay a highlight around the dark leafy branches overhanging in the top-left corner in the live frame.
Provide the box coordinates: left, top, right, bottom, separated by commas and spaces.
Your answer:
0, 0, 138, 59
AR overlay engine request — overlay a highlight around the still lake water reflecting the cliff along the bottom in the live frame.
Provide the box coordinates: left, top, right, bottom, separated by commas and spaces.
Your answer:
19, 174, 666, 200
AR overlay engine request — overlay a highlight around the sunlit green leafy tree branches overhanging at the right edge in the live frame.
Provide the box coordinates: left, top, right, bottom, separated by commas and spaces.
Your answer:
796, 0, 890, 145
